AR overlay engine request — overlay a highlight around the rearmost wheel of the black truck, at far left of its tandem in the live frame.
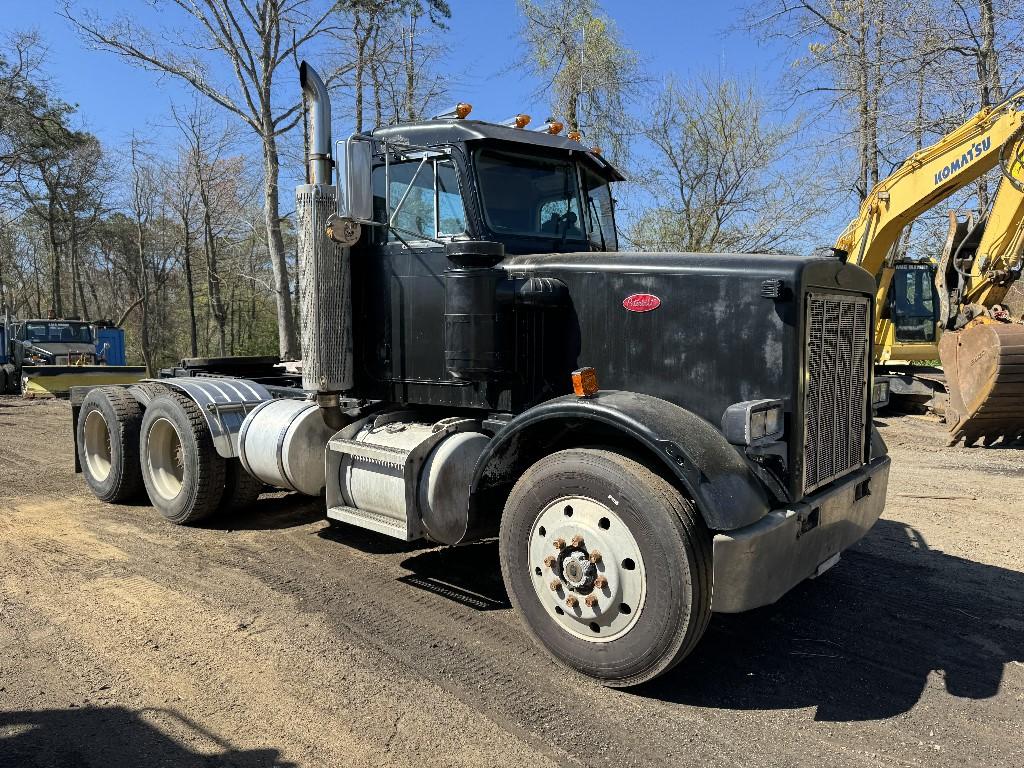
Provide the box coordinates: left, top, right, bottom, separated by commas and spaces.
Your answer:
75, 387, 142, 502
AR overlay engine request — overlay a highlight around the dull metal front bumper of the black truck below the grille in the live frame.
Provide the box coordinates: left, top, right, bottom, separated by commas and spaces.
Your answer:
712, 456, 890, 613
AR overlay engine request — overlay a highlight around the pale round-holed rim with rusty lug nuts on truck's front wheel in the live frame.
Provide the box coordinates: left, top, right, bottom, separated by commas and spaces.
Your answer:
528, 497, 647, 643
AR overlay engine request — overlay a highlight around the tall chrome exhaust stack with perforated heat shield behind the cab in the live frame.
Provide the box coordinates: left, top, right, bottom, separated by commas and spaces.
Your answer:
295, 61, 353, 429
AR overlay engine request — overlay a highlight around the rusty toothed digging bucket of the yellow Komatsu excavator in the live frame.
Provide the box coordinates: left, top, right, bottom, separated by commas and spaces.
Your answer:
939, 323, 1024, 445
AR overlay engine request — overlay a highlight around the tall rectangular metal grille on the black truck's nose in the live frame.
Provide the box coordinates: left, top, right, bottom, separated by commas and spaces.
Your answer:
804, 293, 870, 494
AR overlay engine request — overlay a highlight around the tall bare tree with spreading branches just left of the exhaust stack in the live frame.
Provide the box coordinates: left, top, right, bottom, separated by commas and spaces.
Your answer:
63, 0, 348, 358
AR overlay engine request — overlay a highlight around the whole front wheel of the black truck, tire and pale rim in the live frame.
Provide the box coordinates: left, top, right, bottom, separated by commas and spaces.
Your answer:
499, 449, 712, 686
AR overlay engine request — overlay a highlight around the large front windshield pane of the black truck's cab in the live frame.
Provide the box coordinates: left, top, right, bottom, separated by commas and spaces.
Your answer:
476, 150, 586, 243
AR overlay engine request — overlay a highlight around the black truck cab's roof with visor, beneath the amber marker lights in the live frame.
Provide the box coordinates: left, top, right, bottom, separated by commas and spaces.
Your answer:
369, 118, 625, 181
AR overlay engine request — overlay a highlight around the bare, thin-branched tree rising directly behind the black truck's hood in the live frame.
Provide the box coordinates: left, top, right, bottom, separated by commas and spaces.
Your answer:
628, 77, 828, 253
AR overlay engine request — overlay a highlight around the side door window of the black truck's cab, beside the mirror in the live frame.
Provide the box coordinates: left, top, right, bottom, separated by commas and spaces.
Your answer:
373, 160, 466, 242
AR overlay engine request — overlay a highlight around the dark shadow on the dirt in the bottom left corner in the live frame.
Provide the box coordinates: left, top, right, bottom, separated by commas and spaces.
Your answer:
0, 707, 296, 768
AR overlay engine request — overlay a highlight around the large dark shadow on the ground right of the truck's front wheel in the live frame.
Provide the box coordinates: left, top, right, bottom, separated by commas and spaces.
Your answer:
635, 520, 1024, 721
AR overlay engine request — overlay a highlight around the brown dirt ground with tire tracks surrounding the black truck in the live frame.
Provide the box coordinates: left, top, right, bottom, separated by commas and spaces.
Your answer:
0, 398, 1024, 768
